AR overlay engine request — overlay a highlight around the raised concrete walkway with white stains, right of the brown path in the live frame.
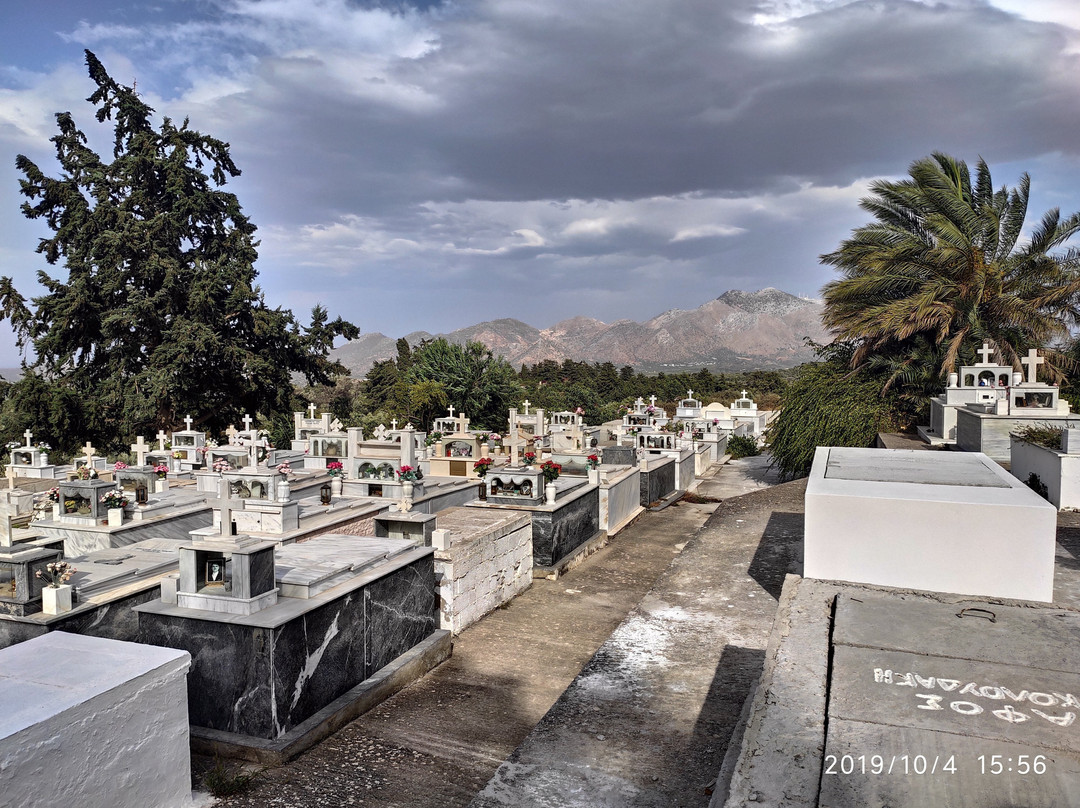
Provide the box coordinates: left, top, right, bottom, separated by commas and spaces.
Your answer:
472, 470, 805, 808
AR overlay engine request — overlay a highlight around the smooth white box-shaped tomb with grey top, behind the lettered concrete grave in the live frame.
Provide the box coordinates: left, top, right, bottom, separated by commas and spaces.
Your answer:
805, 446, 1057, 602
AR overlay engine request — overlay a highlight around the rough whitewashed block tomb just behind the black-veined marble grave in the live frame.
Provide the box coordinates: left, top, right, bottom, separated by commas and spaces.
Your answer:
433, 508, 532, 634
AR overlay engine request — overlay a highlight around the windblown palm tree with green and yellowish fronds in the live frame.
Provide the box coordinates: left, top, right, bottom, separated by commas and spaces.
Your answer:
821, 153, 1080, 383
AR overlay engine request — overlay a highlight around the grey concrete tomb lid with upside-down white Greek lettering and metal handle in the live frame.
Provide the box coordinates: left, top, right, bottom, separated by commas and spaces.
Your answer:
818, 592, 1080, 807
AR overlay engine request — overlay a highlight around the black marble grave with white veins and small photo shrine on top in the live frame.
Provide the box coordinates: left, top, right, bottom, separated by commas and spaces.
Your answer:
136, 533, 448, 743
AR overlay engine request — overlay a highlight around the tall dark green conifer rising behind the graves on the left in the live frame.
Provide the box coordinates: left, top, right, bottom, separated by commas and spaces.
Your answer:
0, 51, 359, 449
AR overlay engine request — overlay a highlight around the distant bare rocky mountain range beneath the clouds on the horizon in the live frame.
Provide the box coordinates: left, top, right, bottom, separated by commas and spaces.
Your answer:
332, 288, 828, 376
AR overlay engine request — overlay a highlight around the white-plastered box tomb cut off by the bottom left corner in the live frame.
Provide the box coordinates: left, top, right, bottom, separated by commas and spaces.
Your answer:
0, 632, 194, 808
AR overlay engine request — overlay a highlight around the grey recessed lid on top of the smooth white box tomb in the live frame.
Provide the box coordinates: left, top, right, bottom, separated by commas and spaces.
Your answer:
825, 447, 1012, 488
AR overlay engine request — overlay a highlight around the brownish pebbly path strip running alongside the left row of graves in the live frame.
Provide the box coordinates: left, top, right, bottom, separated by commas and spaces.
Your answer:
206, 458, 777, 808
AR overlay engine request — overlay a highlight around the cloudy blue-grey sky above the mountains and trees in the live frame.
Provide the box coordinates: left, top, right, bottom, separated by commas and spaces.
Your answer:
0, 0, 1080, 366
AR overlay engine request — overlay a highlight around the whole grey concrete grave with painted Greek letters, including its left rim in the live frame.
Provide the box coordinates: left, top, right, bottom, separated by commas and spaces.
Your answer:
712, 576, 1080, 808
